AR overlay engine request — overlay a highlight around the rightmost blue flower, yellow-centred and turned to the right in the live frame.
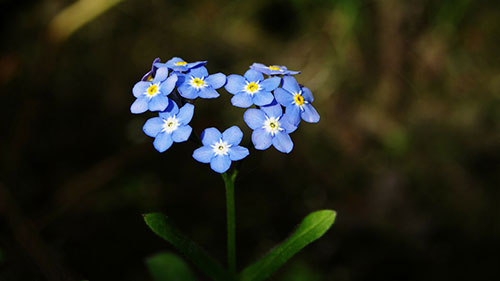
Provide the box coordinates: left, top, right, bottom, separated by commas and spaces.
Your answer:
274, 76, 319, 125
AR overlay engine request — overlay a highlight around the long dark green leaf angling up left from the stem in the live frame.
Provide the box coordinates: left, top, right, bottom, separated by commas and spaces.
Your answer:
144, 213, 229, 281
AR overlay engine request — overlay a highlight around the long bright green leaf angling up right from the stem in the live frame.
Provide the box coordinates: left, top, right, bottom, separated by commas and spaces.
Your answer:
239, 210, 337, 281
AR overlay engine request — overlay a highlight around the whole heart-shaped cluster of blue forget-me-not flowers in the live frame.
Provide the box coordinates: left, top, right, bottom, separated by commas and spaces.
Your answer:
130, 57, 320, 173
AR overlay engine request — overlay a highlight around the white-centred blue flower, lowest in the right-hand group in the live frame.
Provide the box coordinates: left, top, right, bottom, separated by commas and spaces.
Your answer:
243, 102, 297, 153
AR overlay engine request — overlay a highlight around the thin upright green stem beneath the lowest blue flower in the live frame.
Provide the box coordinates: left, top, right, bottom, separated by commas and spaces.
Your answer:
222, 170, 238, 278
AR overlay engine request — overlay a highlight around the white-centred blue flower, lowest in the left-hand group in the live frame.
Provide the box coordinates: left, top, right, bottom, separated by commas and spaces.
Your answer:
142, 102, 194, 152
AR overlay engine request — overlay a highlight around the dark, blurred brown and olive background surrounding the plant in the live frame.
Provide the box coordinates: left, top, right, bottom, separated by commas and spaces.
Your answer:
0, 0, 500, 281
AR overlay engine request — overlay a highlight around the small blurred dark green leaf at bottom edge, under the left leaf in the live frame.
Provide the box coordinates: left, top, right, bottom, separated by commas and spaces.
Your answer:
146, 252, 196, 281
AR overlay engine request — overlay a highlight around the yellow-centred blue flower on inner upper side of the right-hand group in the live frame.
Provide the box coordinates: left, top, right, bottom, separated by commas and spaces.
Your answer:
225, 69, 281, 108
